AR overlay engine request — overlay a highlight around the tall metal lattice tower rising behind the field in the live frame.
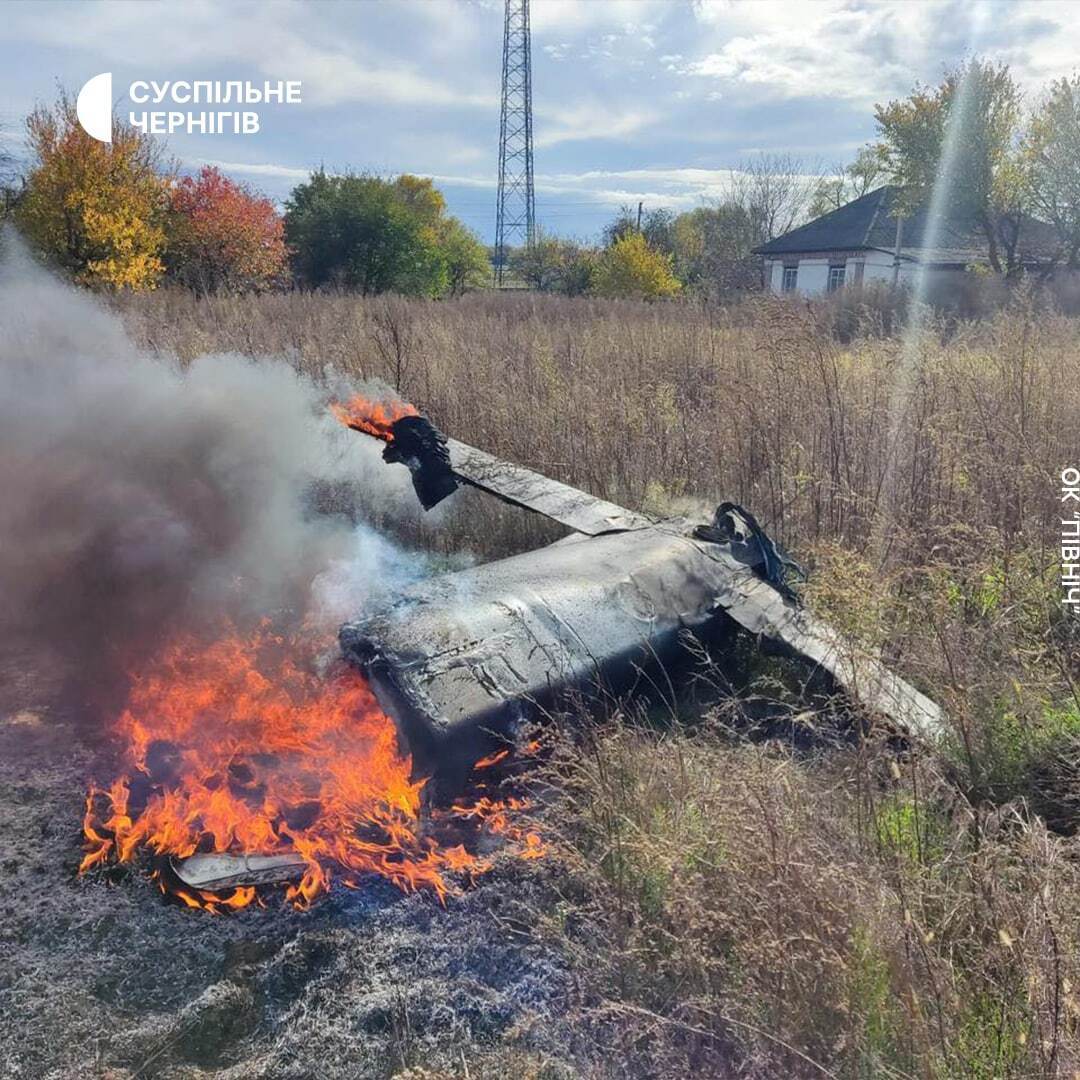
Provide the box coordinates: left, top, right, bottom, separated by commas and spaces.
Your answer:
495, 0, 536, 284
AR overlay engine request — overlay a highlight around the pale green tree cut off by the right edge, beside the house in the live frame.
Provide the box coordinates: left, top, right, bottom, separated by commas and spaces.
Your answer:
1023, 76, 1080, 270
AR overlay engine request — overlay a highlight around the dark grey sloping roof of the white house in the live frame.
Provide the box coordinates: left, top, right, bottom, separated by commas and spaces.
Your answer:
754, 184, 1055, 262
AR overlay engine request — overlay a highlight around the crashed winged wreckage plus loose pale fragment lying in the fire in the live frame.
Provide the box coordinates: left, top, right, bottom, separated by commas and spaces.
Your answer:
164, 399, 942, 892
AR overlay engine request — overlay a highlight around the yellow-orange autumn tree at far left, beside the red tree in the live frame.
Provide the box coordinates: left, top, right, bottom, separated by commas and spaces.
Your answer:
16, 95, 170, 289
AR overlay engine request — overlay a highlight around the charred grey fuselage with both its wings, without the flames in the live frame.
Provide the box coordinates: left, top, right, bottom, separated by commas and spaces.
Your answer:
340, 417, 940, 785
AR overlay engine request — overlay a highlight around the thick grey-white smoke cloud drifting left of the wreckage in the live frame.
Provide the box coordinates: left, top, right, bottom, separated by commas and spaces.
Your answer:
0, 237, 422, 699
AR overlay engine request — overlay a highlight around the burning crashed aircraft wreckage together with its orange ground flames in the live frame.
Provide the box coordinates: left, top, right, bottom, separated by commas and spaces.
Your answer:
83, 397, 942, 910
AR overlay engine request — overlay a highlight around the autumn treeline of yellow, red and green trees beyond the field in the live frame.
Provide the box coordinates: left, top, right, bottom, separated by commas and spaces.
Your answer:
6, 57, 1080, 299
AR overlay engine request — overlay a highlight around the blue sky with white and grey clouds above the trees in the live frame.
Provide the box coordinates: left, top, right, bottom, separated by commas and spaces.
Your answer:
0, 0, 1080, 240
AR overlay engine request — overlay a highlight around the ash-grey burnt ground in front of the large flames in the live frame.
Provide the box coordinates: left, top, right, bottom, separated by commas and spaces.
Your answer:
0, 643, 583, 1080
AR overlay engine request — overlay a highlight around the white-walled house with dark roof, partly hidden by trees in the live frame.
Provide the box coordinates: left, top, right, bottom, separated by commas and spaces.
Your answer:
754, 185, 1055, 296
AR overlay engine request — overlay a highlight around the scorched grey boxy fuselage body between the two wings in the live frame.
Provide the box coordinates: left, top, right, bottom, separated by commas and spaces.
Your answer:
340, 527, 726, 768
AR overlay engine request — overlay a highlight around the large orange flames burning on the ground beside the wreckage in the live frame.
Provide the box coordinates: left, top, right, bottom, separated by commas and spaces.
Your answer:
81, 625, 540, 910
